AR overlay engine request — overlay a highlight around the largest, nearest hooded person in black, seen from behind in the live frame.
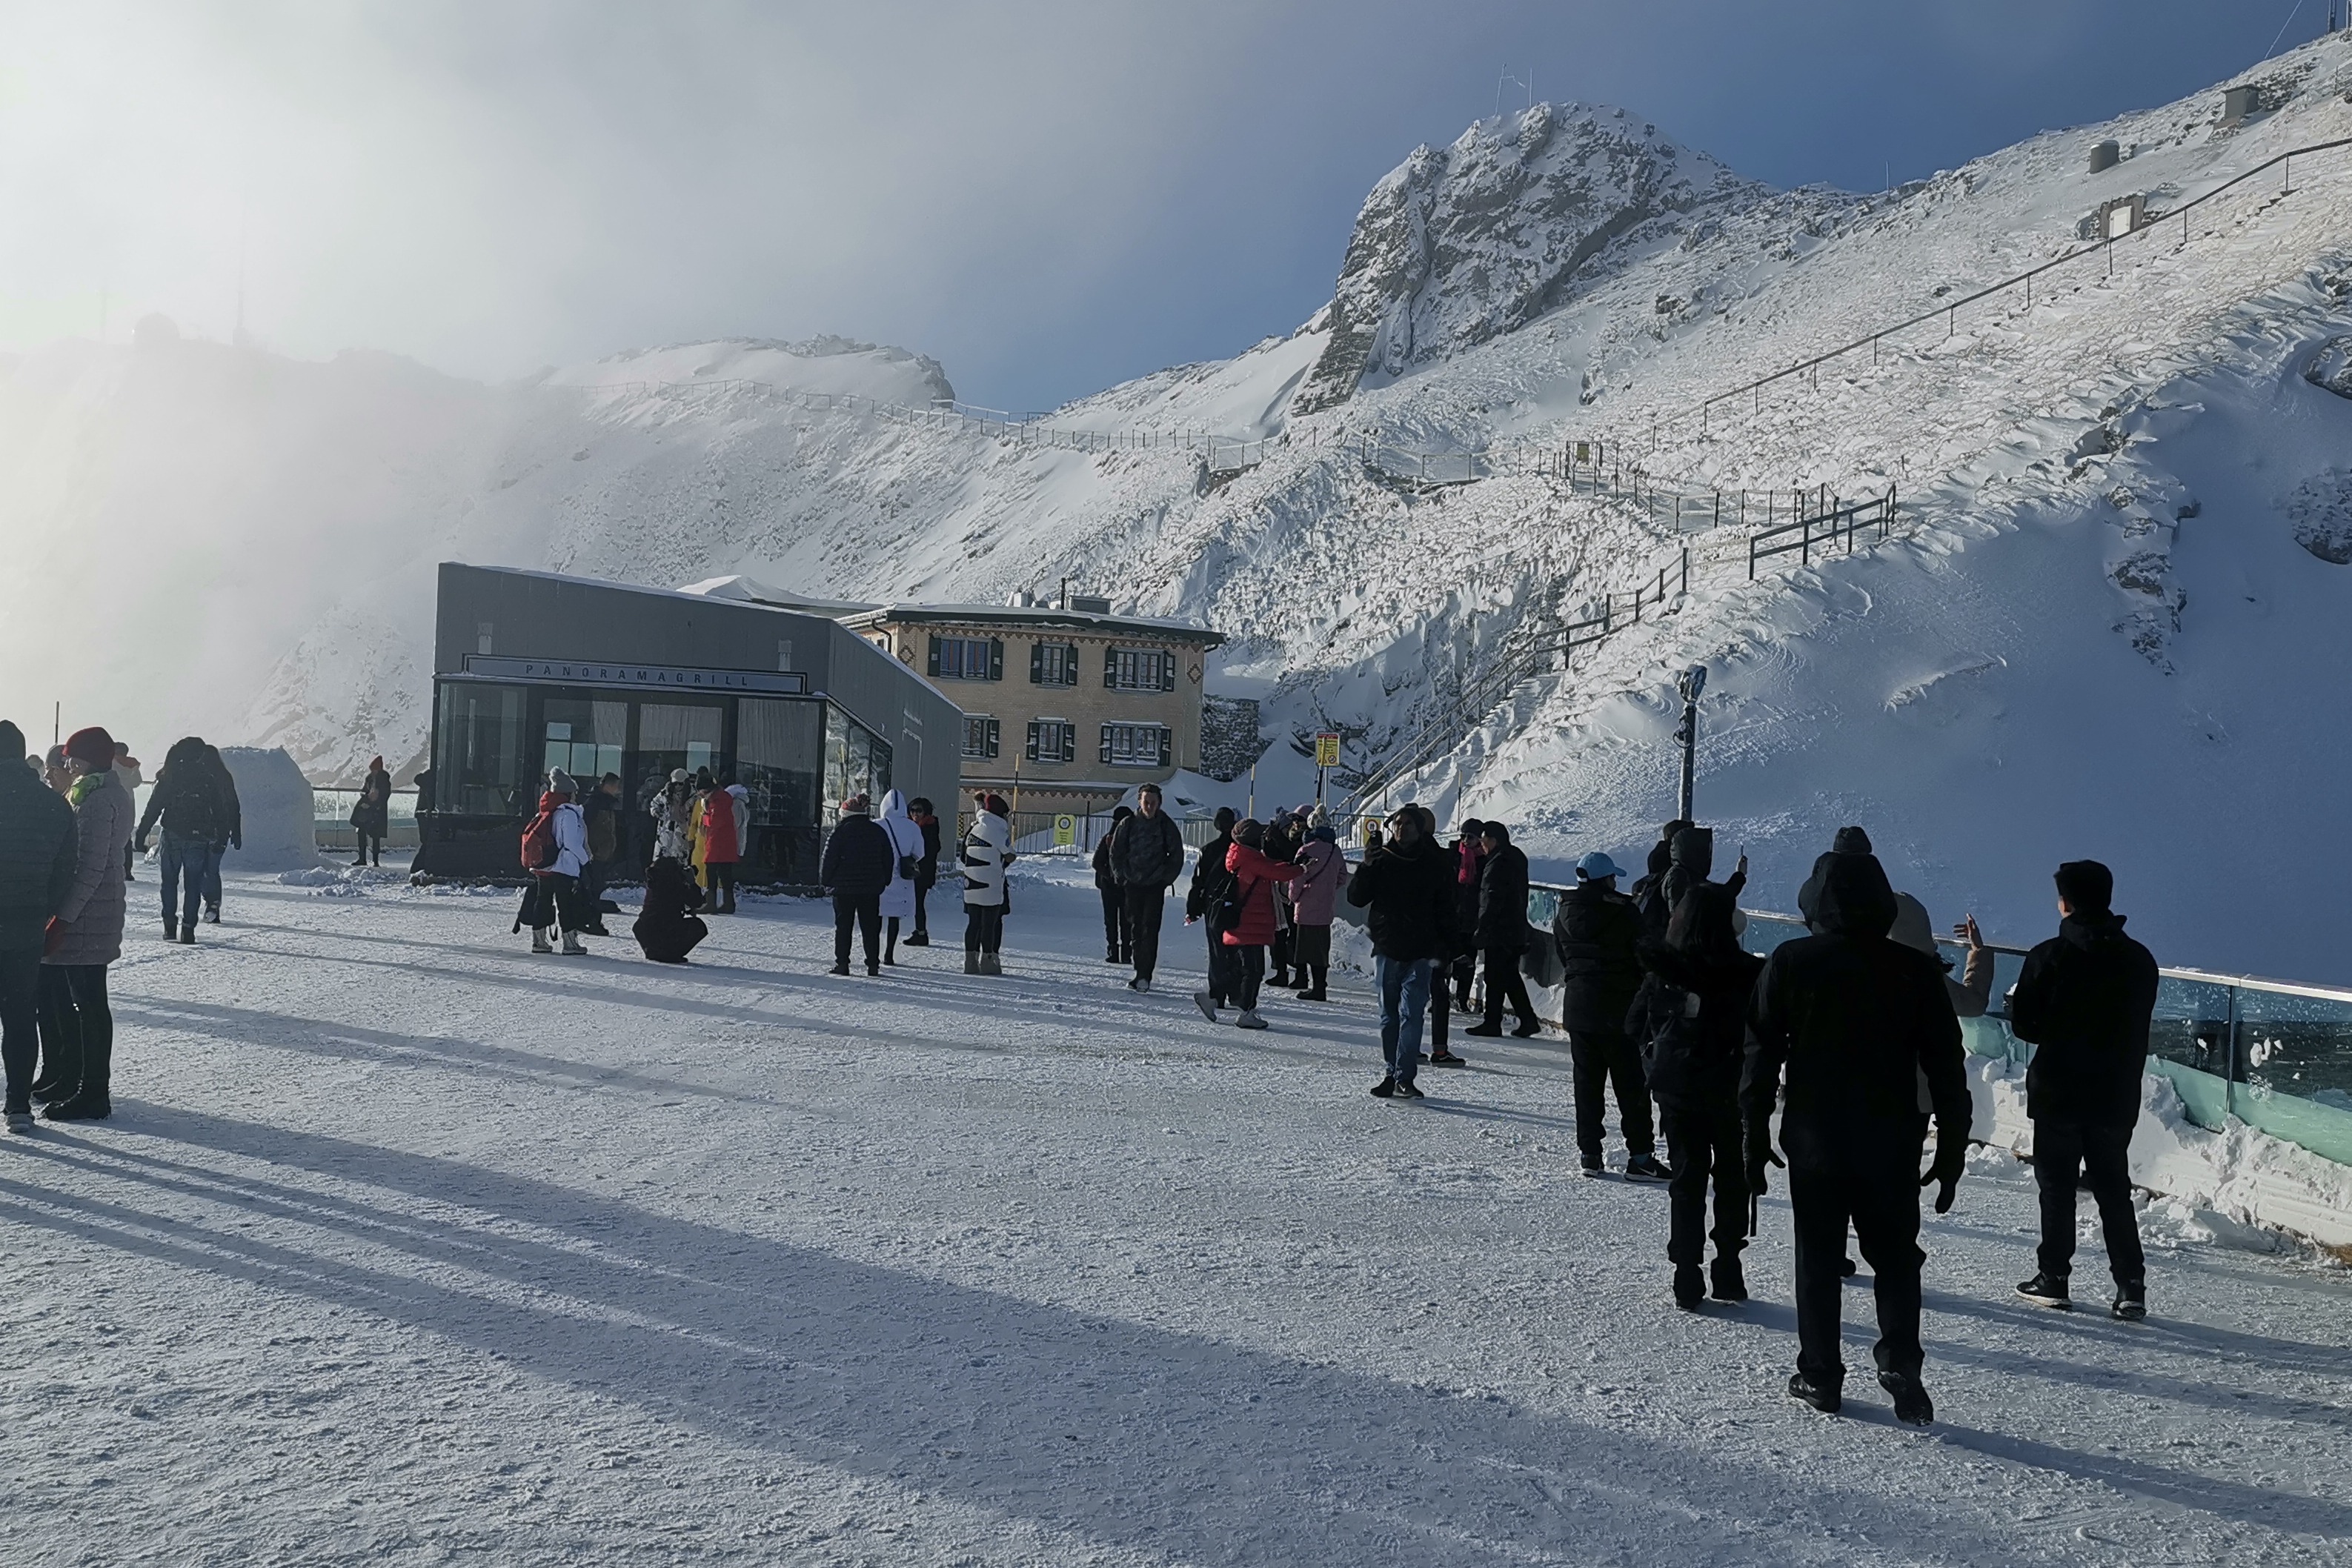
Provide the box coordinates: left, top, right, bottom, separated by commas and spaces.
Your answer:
1741, 856, 1971, 1424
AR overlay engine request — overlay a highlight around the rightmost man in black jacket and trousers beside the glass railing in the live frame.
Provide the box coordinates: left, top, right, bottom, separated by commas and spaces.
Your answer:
2009, 860, 2157, 1321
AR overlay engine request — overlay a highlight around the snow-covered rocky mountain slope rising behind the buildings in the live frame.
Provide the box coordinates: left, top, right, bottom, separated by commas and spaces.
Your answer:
0, 38, 2352, 978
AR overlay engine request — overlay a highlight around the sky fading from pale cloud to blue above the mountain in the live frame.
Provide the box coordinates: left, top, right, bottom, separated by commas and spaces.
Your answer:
0, 0, 2328, 409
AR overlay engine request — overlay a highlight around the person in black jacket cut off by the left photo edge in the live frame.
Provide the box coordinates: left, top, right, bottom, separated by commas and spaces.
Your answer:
0, 720, 80, 1133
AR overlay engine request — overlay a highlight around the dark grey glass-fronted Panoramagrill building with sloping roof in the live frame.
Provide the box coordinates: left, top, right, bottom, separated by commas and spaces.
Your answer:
416, 562, 962, 886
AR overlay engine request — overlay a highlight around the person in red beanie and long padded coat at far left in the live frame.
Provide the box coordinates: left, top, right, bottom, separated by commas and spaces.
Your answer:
33, 728, 132, 1121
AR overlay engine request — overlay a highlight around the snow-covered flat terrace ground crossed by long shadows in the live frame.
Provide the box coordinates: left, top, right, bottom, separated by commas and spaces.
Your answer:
0, 865, 2352, 1566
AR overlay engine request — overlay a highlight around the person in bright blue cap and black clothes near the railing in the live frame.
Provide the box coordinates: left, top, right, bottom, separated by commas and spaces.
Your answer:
1552, 851, 1667, 1183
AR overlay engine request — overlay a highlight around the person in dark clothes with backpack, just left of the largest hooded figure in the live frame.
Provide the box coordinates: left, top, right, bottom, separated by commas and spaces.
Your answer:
1625, 884, 1764, 1312
